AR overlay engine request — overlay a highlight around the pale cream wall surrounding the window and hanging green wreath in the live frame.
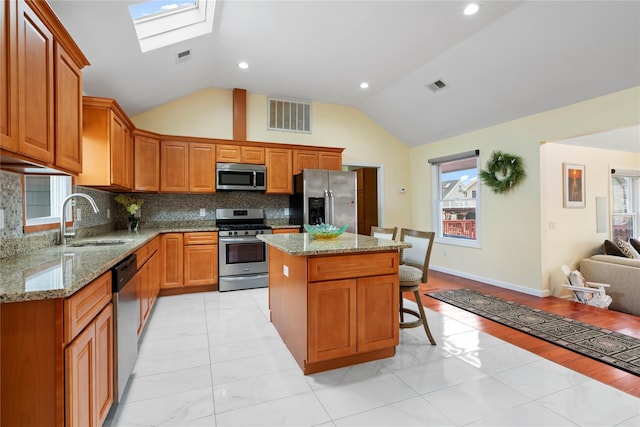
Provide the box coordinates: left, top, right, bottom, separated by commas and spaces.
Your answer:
410, 87, 640, 295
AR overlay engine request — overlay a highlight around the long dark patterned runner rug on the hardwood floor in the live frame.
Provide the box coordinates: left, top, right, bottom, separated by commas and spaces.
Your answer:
426, 289, 640, 376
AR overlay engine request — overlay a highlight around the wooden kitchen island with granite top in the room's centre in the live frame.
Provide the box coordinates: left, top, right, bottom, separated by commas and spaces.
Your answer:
258, 233, 409, 374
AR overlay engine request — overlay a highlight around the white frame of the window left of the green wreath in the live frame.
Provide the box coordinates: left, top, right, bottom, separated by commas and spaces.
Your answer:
429, 150, 482, 249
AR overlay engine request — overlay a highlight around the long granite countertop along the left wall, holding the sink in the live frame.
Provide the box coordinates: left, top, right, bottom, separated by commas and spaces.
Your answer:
0, 227, 218, 303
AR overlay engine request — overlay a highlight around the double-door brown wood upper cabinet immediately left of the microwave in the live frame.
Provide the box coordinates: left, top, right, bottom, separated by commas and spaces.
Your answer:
160, 141, 216, 193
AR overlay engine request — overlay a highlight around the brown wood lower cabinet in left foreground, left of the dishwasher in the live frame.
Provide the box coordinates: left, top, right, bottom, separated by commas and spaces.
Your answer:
0, 271, 114, 427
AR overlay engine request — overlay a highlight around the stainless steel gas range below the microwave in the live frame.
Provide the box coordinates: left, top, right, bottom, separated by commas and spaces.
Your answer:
216, 209, 271, 292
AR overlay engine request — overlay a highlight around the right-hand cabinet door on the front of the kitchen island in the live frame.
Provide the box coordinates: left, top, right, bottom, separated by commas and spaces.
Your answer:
357, 274, 400, 352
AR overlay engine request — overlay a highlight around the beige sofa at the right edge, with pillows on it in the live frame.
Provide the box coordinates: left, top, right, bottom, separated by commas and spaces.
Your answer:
580, 255, 640, 316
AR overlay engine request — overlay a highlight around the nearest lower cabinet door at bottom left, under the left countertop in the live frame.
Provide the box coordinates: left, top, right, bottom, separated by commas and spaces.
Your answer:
65, 323, 96, 427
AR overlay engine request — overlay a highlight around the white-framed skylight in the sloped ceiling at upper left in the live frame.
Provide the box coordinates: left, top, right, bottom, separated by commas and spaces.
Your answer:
129, 0, 215, 52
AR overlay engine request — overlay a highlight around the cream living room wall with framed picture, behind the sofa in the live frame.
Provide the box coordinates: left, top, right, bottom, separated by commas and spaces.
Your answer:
540, 143, 640, 296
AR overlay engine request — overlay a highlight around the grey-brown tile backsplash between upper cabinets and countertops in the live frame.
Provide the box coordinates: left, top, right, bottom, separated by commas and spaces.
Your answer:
0, 171, 289, 258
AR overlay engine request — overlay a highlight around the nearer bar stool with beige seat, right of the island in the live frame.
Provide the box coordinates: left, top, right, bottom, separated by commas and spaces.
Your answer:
399, 228, 436, 345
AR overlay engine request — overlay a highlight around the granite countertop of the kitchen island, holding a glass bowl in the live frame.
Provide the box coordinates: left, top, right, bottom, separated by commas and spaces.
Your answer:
257, 233, 411, 256
